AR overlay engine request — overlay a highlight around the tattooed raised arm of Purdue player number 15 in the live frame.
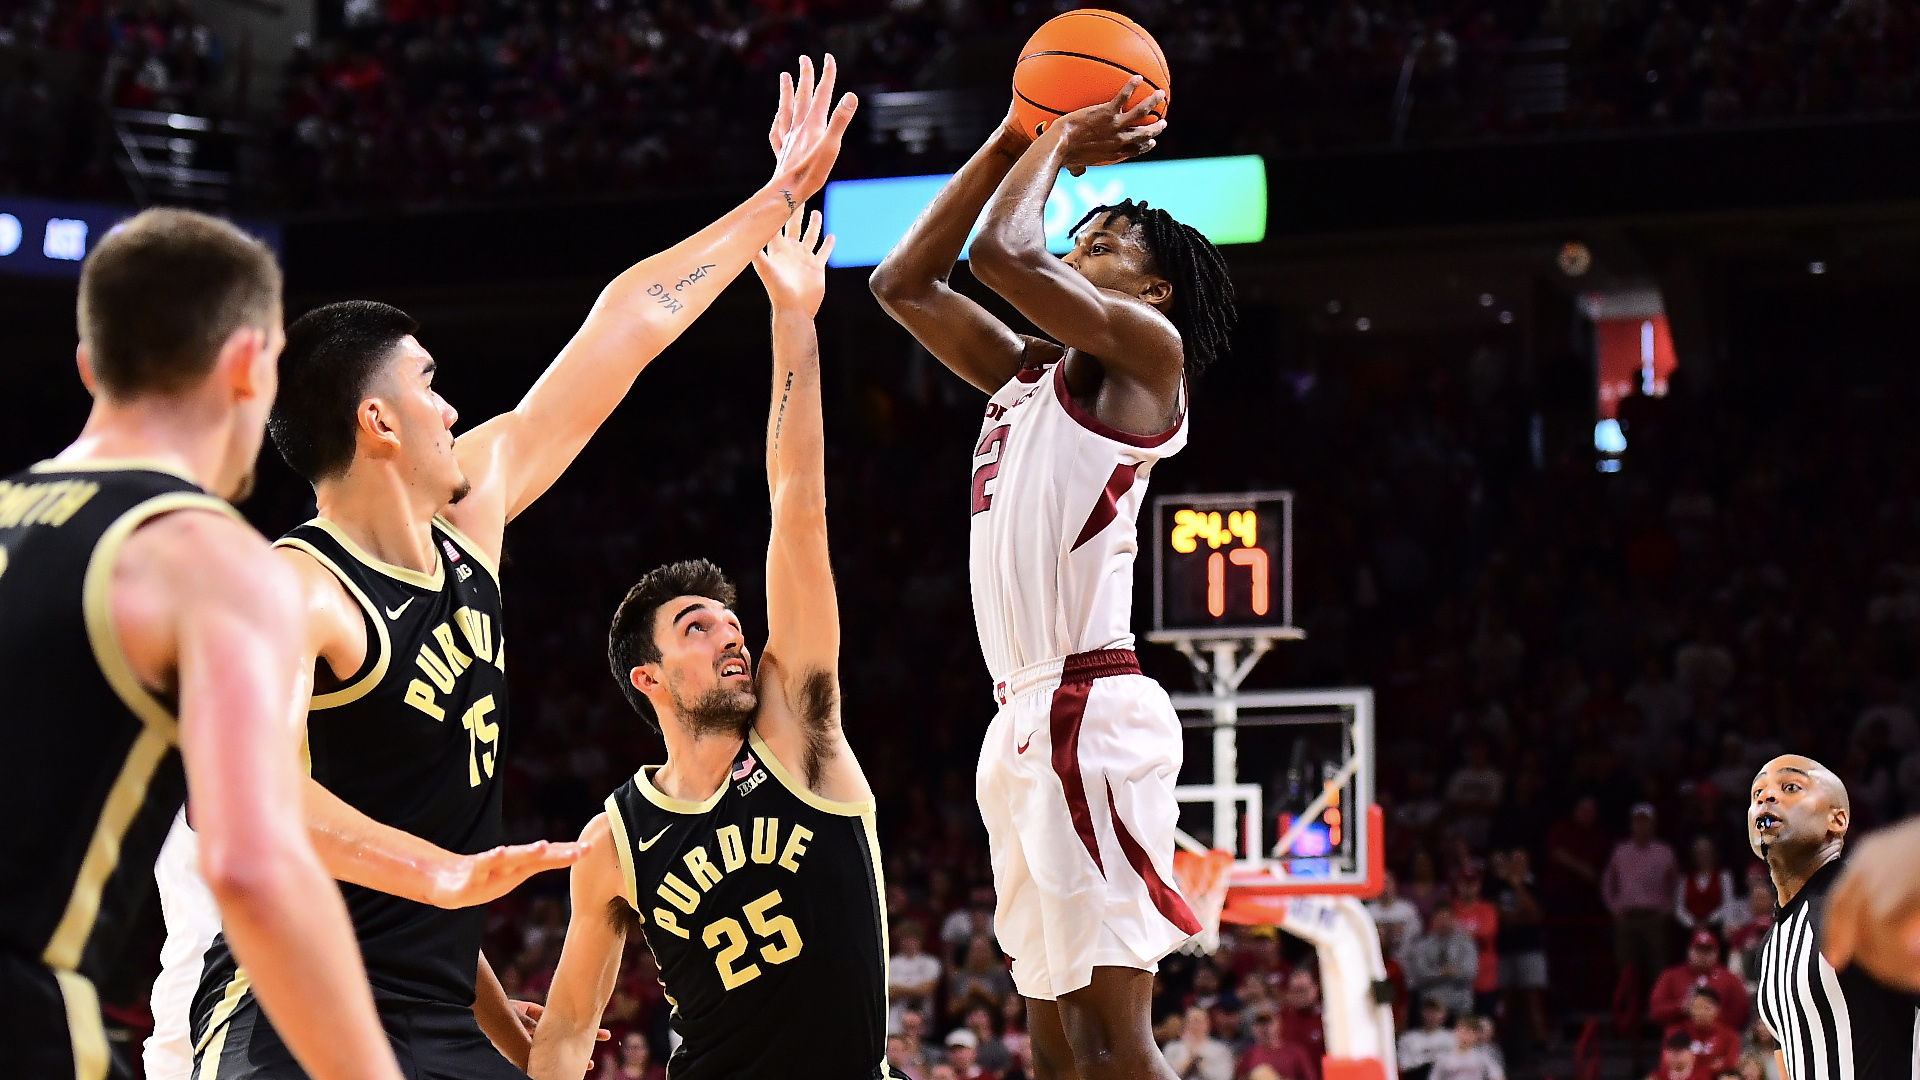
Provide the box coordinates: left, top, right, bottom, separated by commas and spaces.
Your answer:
447, 56, 858, 553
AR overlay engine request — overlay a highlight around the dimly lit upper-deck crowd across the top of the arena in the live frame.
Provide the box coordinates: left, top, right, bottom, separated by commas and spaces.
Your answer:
15, 0, 1920, 209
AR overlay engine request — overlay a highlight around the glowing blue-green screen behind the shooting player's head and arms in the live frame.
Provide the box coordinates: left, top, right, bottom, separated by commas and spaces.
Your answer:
826, 154, 1267, 267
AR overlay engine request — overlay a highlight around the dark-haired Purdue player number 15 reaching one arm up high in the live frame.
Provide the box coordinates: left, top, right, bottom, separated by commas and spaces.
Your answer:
157, 56, 856, 1080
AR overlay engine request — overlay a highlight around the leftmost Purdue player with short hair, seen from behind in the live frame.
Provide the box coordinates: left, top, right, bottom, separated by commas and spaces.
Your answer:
0, 209, 399, 1080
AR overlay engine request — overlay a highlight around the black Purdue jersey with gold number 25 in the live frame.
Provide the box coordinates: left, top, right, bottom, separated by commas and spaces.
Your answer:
607, 734, 887, 1080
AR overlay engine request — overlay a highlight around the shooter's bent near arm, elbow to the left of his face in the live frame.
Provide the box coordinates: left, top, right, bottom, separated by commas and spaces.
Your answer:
973, 77, 1181, 379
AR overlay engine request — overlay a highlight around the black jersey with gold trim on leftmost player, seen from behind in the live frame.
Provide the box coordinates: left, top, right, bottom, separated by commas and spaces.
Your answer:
0, 461, 238, 1076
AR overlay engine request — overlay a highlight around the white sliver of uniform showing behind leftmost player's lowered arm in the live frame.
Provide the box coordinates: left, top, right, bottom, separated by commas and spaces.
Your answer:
144, 809, 221, 1080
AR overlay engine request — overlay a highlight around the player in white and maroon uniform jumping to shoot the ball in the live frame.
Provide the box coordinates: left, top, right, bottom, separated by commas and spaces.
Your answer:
872, 79, 1235, 1080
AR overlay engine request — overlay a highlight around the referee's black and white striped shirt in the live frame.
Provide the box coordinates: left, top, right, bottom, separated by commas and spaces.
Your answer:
1755, 859, 1920, 1080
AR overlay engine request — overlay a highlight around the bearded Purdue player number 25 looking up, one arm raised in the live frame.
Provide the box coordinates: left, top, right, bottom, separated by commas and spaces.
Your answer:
530, 205, 887, 1080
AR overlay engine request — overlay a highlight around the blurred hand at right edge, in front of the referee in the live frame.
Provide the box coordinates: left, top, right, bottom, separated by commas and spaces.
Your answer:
1820, 821, 1920, 992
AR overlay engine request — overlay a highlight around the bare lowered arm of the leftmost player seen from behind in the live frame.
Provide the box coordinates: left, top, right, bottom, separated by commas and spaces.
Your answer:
150, 513, 399, 1080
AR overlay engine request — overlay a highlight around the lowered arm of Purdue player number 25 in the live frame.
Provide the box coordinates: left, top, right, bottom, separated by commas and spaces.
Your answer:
526, 813, 637, 1080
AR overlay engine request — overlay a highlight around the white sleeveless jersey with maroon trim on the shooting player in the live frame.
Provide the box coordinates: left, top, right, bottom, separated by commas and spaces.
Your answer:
970, 361, 1187, 682
